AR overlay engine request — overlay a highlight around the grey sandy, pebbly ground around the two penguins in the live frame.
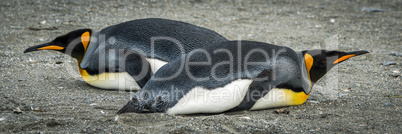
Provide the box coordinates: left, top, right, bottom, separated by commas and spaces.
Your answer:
0, 0, 402, 133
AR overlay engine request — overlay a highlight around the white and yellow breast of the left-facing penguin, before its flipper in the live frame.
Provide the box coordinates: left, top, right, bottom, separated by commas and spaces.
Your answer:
82, 72, 140, 91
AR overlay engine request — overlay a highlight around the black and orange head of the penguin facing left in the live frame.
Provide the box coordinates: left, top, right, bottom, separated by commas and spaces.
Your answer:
24, 29, 92, 61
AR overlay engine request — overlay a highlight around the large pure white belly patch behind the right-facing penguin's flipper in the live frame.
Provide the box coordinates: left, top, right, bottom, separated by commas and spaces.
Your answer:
166, 79, 252, 114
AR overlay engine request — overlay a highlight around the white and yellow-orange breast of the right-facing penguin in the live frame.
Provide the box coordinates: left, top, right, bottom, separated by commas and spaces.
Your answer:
250, 88, 308, 110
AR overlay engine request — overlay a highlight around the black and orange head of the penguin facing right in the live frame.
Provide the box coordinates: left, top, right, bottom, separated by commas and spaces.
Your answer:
302, 50, 368, 83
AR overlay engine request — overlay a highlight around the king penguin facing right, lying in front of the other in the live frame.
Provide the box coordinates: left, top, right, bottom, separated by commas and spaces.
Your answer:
117, 41, 368, 115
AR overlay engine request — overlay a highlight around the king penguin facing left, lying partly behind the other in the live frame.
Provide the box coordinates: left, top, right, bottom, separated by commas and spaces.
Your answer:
24, 18, 227, 90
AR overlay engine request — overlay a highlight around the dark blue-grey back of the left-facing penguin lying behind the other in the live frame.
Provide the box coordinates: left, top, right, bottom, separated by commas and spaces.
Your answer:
99, 18, 228, 61
